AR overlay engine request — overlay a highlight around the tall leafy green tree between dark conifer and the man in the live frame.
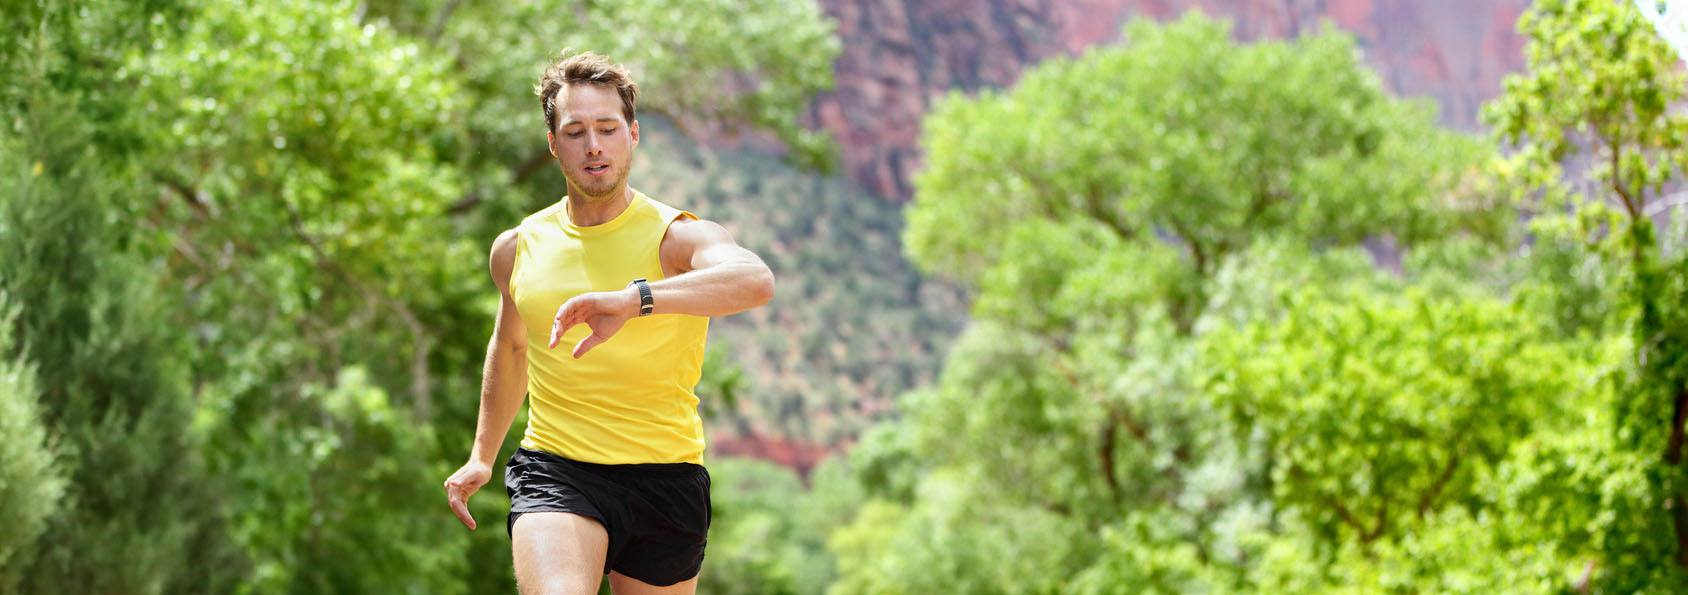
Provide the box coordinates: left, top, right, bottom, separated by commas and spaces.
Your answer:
125, 2, 484, 592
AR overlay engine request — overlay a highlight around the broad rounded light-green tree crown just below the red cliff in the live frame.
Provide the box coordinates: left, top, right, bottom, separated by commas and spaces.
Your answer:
906, 14, 1506, 297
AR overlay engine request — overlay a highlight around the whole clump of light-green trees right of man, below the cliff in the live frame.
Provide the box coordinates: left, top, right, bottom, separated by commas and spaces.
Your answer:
830, 10, 1641, 593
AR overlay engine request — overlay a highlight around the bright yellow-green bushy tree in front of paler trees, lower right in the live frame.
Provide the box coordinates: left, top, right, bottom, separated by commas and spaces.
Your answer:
1202, 275, 1605, 590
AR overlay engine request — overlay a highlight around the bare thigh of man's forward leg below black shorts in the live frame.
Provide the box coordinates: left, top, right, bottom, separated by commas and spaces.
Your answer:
510, 512, 609, 595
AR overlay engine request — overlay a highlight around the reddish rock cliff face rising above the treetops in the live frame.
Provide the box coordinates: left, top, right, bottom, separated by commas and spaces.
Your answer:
810, 0, 1526, 201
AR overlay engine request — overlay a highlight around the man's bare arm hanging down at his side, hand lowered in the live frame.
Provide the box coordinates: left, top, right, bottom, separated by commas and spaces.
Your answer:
446, 230, 527, 529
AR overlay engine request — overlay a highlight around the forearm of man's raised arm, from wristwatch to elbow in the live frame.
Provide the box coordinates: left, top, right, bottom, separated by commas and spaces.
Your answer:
644, 262, 773, 316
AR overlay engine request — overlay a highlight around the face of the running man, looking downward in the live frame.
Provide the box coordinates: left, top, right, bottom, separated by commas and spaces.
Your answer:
549, 85, 638, 198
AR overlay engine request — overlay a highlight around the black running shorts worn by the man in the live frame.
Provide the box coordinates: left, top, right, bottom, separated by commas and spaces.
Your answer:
505, 448, 714, 587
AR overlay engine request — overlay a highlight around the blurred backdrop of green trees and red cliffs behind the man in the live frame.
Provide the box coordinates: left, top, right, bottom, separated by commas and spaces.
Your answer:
0, 0, 1688, 593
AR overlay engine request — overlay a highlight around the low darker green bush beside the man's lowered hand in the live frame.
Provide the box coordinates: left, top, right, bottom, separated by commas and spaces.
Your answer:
201, 368, 469, 593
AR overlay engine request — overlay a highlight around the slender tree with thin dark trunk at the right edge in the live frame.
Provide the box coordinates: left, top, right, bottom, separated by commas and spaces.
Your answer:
1484, 0, 1688, 592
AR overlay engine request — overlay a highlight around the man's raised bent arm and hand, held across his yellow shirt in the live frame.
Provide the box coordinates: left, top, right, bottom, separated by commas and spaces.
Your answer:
550, 220, 773, 357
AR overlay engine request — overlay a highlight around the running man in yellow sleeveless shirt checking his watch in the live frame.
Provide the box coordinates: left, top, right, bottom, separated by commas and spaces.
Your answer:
446, 52, 773, 595
